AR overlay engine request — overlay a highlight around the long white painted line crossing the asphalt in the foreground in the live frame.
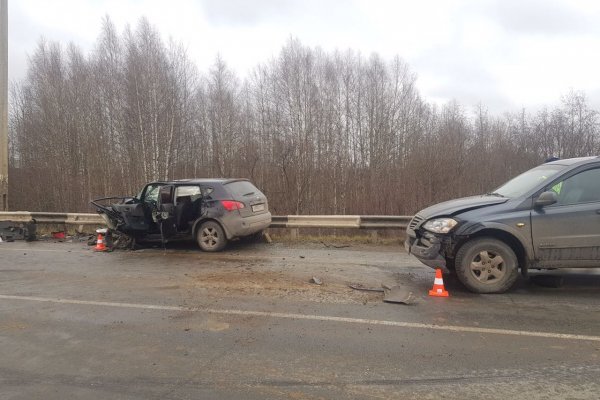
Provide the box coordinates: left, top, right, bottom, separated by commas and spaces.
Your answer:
0, 294, 600, 342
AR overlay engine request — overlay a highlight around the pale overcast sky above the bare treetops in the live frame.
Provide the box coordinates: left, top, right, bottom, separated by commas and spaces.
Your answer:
8, 0, 600, 113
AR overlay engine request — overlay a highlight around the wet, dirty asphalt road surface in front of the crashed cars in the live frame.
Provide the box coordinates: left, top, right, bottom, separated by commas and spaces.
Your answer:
0, 242, 600, 400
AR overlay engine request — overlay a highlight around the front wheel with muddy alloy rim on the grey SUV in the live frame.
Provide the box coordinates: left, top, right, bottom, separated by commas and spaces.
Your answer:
455, 238, 519, 293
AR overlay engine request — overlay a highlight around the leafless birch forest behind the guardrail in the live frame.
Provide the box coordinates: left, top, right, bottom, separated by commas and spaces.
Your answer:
9, 18, 600, 215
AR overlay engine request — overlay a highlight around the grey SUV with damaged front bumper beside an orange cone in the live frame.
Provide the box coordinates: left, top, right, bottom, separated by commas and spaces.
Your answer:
405, 157, 600, 293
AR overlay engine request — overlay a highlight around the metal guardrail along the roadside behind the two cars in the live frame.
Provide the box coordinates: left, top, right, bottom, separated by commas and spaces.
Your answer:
0, 211, 412, 230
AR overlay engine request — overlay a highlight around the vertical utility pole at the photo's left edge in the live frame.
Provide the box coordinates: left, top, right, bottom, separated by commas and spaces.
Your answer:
0, 0, 8, 211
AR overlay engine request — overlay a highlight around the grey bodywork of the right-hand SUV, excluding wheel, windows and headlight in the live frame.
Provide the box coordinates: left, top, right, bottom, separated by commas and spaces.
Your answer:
405, 157, 600, 271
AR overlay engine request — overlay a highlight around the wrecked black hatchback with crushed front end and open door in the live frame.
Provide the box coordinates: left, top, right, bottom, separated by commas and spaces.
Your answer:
91, 179, 271, 251
